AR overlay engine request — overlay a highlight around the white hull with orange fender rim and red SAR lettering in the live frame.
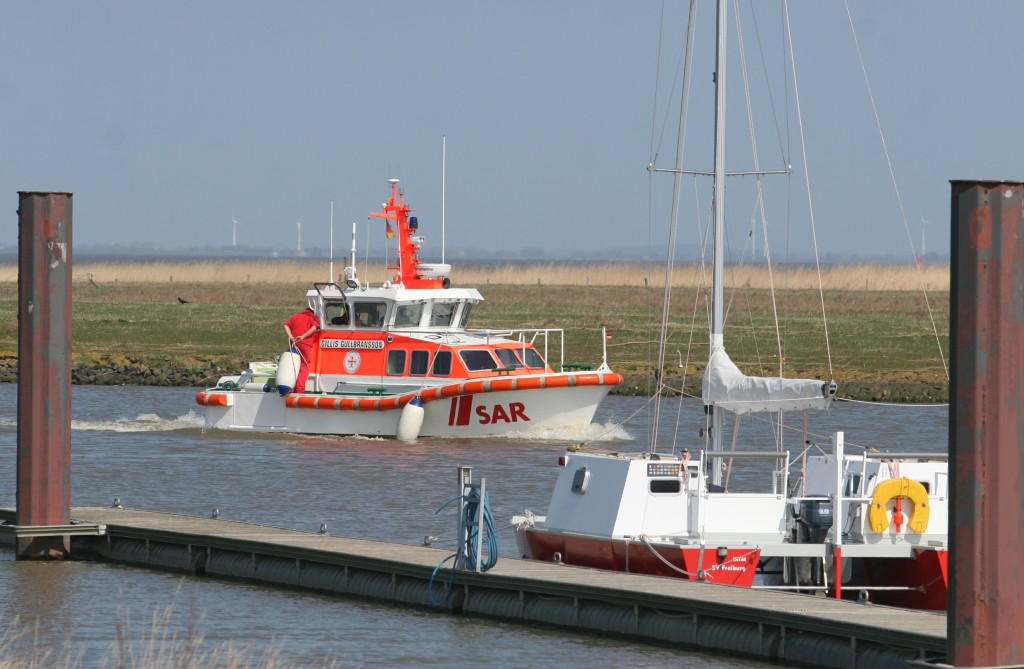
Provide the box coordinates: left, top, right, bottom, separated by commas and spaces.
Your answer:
197, 372, 622, 438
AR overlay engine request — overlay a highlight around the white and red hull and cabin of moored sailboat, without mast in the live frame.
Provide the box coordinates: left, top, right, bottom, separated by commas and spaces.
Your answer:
512, 451, 949, 610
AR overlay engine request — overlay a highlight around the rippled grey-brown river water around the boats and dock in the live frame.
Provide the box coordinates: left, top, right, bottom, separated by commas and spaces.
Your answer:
0, 384, 947, 668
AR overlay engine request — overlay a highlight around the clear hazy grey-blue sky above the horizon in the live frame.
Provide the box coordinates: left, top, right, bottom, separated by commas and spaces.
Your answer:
0, 0, 1024, 260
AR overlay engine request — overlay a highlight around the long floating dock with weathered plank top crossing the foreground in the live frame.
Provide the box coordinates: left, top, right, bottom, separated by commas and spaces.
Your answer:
0, 507, 946, 669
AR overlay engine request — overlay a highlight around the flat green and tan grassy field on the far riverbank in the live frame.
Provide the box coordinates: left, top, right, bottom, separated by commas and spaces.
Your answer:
0, 261, 949, 395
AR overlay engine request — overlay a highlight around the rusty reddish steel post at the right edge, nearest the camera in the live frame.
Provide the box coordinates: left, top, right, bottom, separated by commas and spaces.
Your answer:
946, 181, 1024, 667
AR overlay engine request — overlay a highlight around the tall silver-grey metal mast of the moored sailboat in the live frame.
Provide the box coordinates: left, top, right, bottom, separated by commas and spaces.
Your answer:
710, 0, 728, 456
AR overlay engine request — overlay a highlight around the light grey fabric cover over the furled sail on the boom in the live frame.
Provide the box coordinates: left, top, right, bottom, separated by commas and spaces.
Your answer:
702, 348, 836, 414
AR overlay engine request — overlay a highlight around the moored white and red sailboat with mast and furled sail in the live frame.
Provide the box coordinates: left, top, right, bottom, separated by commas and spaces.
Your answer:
512, 1, 948, 610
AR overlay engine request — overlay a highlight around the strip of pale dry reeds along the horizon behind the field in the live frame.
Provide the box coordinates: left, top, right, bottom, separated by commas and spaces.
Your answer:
0, 260, 949, 292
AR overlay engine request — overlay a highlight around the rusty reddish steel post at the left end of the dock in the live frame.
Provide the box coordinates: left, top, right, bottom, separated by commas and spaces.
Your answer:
15, 192, 72, 559
